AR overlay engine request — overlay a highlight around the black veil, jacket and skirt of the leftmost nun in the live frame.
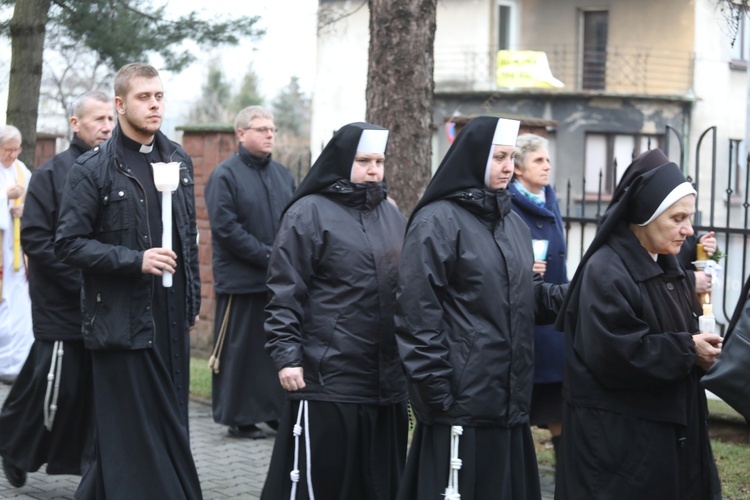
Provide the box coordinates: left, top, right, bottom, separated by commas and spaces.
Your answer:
261, 123, 408, 500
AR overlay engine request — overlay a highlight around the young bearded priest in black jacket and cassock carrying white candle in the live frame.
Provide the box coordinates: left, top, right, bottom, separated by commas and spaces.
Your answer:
55, 63, 202, 500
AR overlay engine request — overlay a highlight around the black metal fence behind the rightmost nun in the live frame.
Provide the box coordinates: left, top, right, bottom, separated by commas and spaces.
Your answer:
561, 127, 750, 328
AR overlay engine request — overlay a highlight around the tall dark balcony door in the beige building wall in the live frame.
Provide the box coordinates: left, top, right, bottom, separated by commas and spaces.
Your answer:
581, 10, 609, 90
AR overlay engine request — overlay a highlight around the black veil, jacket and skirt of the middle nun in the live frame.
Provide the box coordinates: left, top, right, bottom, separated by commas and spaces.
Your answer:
396, 117, 566, 500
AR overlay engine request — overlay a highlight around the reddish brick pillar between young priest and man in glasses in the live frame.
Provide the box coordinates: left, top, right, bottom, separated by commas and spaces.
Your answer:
179, 125, 237, 354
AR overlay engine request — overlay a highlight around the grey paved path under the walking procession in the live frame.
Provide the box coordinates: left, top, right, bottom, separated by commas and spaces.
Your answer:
0, 384, 554, 500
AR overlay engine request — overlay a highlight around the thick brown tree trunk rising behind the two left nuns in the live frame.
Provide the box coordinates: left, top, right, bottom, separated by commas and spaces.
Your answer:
366, 0, 436, 214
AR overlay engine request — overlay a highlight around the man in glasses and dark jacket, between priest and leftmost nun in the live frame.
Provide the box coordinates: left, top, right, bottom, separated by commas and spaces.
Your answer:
206, 106, 294, 439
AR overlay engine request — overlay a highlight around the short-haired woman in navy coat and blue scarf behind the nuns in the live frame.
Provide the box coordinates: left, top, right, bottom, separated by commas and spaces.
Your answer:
508, 134, 568, 476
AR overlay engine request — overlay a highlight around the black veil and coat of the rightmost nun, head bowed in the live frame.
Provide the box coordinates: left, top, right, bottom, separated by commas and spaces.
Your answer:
555, 163, 721, 500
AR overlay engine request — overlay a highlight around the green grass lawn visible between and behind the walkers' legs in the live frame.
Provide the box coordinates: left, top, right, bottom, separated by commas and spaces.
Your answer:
190, 357, 750, 500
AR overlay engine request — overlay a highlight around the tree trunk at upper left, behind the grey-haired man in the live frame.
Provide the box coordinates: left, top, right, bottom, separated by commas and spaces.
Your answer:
6, 0, 51, 168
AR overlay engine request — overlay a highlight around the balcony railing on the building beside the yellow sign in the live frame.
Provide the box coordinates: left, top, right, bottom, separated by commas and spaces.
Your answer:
435, 45, 694, 96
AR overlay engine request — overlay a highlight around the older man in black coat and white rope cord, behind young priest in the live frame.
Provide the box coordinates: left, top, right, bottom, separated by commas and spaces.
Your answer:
0, 91, 114, 487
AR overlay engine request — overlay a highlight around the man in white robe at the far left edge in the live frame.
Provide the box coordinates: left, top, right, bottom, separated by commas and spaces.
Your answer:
0, 125, 34, 383
